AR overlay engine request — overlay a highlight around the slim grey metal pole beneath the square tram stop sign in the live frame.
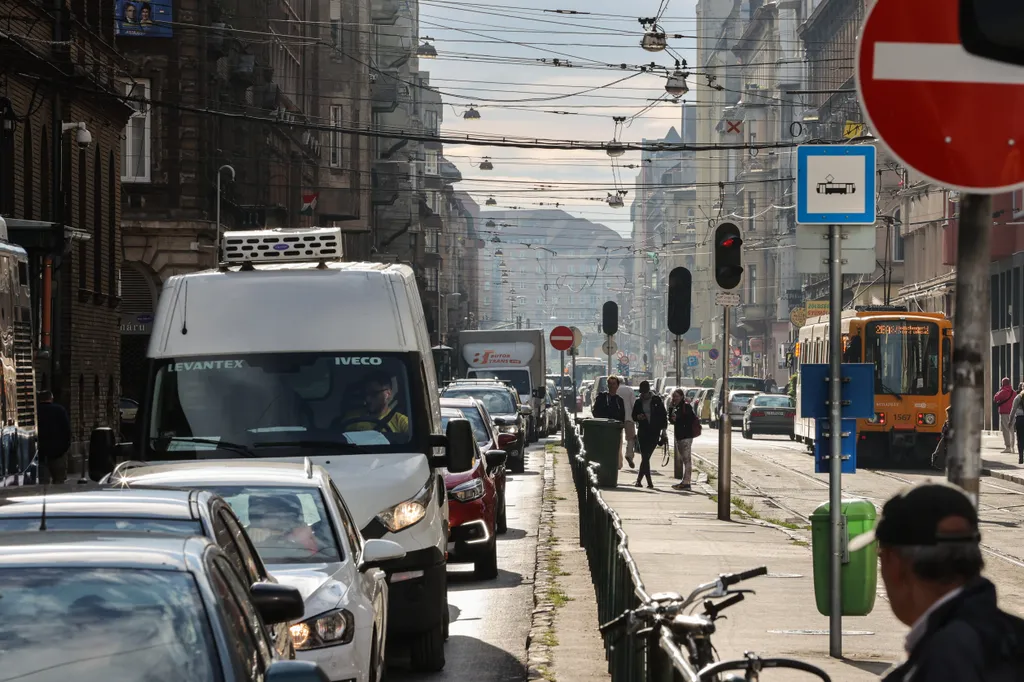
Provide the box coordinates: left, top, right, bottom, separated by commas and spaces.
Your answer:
828, 225, 845, 658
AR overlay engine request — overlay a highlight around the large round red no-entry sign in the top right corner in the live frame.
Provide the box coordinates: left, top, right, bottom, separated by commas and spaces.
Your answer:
855, 0, 1024, 194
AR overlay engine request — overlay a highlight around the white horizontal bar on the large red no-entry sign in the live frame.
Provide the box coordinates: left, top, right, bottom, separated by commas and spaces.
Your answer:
871, 42, 1024, 85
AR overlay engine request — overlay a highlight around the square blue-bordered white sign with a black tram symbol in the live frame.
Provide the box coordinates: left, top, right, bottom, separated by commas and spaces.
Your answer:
797, 144, 876, 224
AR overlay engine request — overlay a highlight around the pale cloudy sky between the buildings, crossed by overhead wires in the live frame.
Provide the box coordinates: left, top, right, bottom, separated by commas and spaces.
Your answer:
420, 0, 699, 237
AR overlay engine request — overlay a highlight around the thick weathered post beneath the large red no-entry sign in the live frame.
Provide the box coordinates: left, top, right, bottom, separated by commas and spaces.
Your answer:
946, 194, 992, 507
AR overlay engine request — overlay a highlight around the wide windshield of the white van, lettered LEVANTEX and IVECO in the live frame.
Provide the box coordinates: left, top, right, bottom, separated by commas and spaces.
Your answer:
143, 352, 416, 460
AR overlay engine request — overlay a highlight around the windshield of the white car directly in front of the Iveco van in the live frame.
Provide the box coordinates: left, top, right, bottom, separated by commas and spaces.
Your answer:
203, 485, 344, 565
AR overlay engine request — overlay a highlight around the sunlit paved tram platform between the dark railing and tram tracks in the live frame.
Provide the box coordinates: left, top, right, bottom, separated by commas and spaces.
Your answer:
598, 456, 907, 682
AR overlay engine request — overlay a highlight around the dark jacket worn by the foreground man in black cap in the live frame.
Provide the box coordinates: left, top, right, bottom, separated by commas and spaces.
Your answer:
882, 578, 1024, 682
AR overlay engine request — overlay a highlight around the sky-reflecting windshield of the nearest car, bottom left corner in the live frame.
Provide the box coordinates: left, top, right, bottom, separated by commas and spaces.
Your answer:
0, 567, 220, 682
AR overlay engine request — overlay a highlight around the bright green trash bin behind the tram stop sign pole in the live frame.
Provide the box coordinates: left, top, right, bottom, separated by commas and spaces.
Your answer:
811, 499, 879, 615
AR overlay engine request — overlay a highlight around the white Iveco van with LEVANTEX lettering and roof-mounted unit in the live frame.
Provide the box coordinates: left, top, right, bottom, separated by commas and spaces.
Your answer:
92, 228, 476, 671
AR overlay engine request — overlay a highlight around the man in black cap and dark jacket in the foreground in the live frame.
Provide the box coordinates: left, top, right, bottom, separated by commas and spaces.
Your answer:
850, 482, 1024, 682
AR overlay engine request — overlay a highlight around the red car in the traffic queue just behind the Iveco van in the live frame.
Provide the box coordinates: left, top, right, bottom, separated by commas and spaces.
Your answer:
441, 398, 508, 580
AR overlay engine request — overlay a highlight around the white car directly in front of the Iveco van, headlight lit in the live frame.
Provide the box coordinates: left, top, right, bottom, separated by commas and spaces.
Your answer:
111, 460, 406, 682
